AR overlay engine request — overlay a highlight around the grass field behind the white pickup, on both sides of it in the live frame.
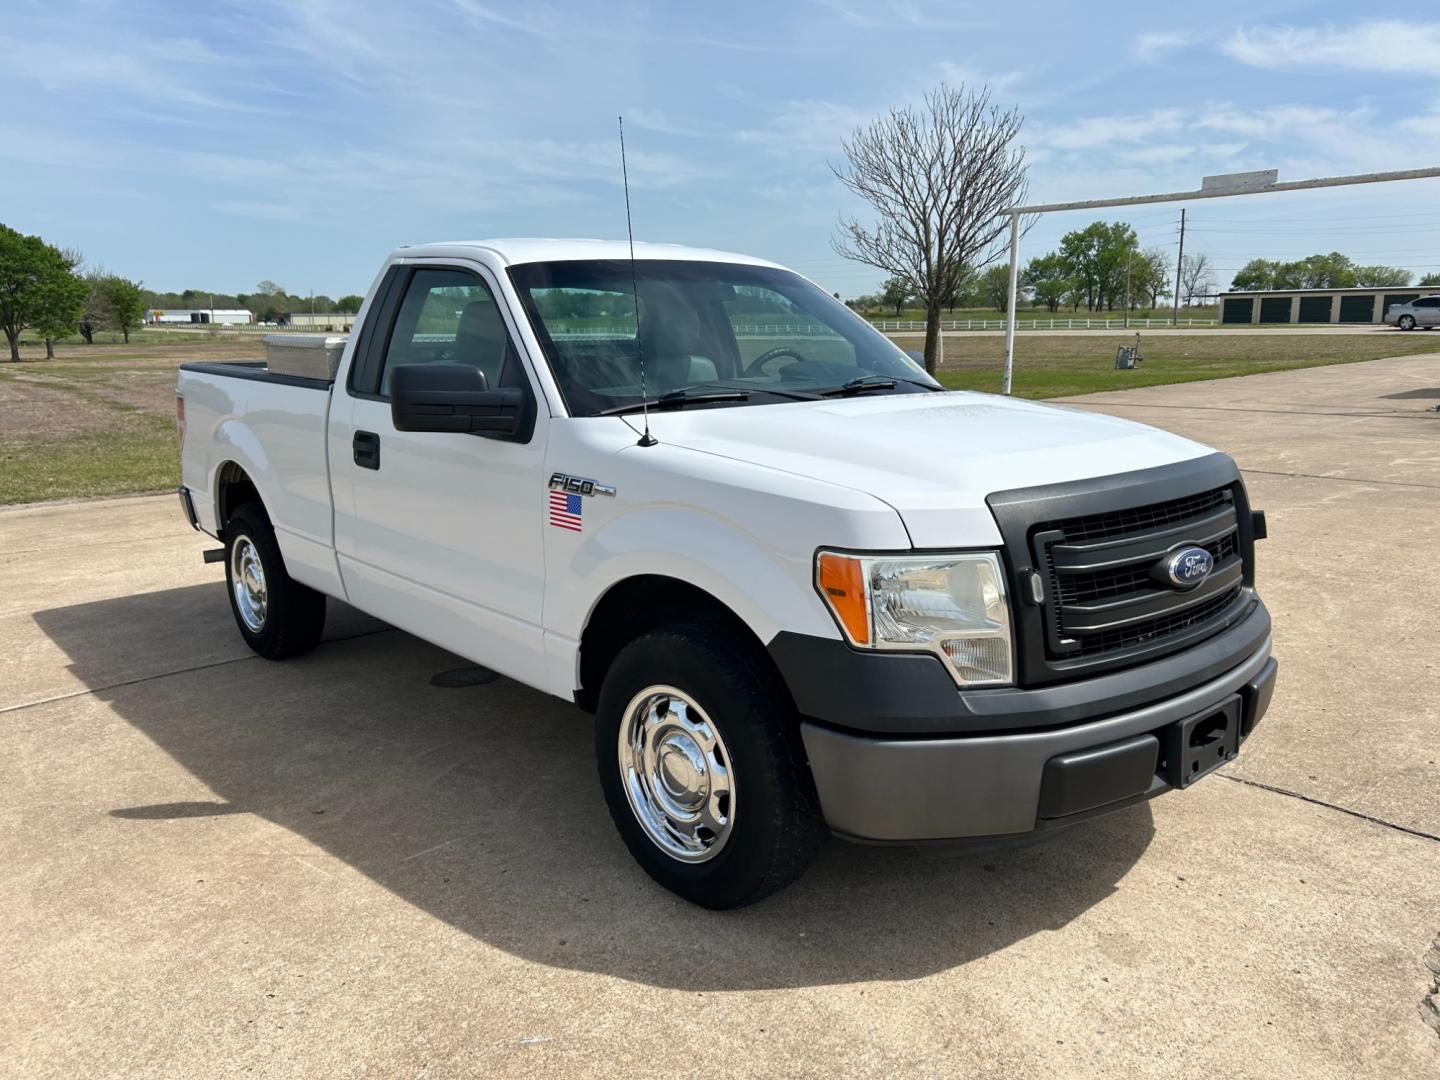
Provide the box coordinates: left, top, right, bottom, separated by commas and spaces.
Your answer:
0, 331, 1440, 504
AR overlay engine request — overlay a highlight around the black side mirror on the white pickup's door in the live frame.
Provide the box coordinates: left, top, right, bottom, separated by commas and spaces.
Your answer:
390, 364, 524, 435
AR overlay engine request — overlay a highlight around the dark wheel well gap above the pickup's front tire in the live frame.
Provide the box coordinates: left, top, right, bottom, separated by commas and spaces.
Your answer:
575, 575, 770, 713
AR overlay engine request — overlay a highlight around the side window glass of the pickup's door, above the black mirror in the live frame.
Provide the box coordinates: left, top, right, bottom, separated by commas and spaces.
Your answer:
380, 268, 526, 396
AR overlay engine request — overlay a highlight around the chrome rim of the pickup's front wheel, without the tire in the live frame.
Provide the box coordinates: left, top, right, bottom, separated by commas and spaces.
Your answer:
619, 685, 734, 863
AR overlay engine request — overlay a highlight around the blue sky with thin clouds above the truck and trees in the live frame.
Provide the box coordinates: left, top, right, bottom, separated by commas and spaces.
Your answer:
0, 0, 1440, 297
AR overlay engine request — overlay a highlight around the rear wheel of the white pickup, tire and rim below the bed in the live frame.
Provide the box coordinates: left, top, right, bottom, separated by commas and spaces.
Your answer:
225, 503, 325, 660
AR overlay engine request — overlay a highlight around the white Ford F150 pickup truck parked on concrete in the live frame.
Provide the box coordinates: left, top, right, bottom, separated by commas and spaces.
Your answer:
177, 240, 1276, 907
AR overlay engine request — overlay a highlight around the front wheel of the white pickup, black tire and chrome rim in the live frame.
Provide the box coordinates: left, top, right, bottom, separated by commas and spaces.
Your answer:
595, 625, 828, 909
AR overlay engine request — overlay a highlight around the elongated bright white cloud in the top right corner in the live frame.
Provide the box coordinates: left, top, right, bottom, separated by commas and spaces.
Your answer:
1221, 21, 1440, 75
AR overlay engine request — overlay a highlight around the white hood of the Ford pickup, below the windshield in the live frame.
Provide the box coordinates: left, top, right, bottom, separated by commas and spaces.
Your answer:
634, 392, 1214, 547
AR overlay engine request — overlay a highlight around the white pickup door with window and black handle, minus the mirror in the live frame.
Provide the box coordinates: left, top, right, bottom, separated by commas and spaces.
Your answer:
328, 262, 547, 685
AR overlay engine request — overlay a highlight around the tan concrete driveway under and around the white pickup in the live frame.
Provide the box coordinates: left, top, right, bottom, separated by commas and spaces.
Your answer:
8, 357, 1440, 1080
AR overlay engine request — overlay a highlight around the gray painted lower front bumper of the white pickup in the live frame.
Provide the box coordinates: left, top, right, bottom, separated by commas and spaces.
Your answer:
801, 635, 1274, 841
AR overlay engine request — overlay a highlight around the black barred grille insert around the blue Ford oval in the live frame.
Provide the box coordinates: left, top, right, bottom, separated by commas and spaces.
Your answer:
1030, 487, 1244, 661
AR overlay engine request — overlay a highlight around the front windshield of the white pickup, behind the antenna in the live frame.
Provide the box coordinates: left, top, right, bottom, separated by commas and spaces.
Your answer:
510, 259, 940, 416
